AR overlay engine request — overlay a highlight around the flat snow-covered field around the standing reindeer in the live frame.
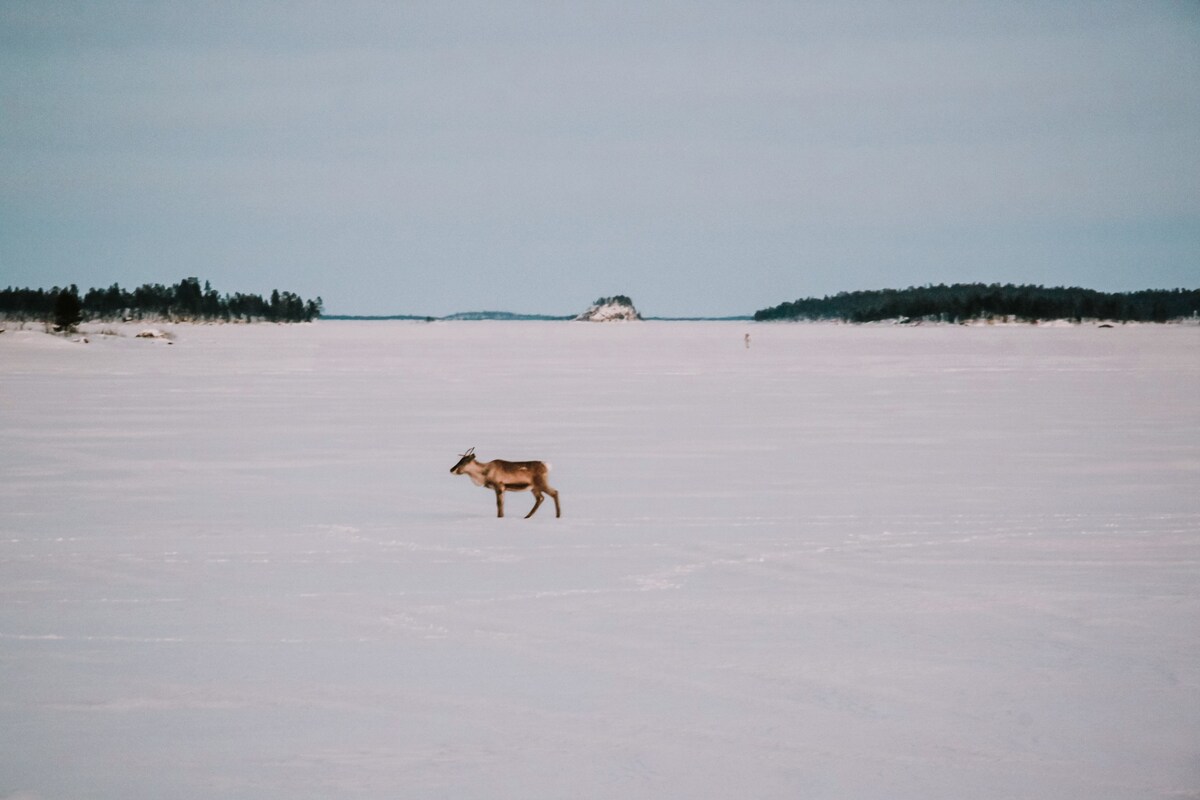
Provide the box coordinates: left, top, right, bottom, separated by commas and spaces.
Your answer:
0, 321, 1200, 800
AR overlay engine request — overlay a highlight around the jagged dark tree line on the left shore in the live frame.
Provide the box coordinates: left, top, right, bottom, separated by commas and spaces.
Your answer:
0, 278, 322, 327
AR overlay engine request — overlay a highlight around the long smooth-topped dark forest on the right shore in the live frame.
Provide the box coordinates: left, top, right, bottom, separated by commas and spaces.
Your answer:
754, 283, 1200, 323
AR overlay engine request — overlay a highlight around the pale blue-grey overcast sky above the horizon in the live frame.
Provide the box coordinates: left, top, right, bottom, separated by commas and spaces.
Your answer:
0, 0, 1200, 315
